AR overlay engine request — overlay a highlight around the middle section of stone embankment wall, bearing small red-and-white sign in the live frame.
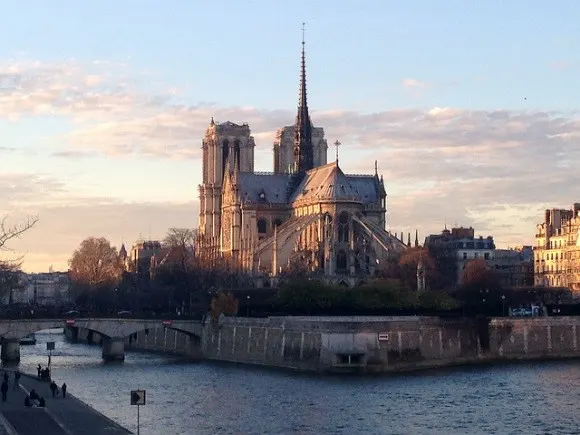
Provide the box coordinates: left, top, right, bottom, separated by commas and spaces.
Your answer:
202, 317, 480, 372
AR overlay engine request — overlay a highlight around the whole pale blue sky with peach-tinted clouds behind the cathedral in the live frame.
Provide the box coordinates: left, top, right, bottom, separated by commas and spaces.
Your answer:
0, 0, 580, 272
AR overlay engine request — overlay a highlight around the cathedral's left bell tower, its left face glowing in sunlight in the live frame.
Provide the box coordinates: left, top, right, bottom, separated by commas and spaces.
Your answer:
199, 118, 256, 246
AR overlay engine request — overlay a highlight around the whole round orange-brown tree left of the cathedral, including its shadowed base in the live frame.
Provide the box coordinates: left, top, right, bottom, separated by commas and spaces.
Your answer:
69, 237, 123, 309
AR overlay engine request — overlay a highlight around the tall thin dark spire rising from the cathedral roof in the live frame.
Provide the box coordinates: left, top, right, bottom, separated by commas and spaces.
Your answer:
294, 23, 314, 173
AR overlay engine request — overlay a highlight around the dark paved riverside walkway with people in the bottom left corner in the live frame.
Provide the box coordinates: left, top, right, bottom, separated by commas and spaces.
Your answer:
0, 372, 132, 435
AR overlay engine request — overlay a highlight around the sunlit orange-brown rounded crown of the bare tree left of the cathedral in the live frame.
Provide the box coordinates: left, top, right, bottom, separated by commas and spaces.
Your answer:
69, 237, 123, 288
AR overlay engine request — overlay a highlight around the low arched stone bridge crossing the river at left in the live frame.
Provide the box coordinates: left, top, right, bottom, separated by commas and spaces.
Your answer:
0, 319, 203, 362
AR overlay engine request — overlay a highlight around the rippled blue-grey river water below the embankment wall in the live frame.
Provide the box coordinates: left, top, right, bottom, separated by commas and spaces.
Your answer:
7, 331, 580, 435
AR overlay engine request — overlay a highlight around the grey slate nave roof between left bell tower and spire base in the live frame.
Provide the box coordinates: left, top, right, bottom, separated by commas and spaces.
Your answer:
237, 172, 290, 204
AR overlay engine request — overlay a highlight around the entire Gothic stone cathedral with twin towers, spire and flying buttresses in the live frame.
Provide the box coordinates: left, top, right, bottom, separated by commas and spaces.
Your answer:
198, 36, 406, 286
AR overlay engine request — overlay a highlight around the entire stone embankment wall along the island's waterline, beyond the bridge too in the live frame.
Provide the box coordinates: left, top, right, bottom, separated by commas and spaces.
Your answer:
64, 317, 580, 372
